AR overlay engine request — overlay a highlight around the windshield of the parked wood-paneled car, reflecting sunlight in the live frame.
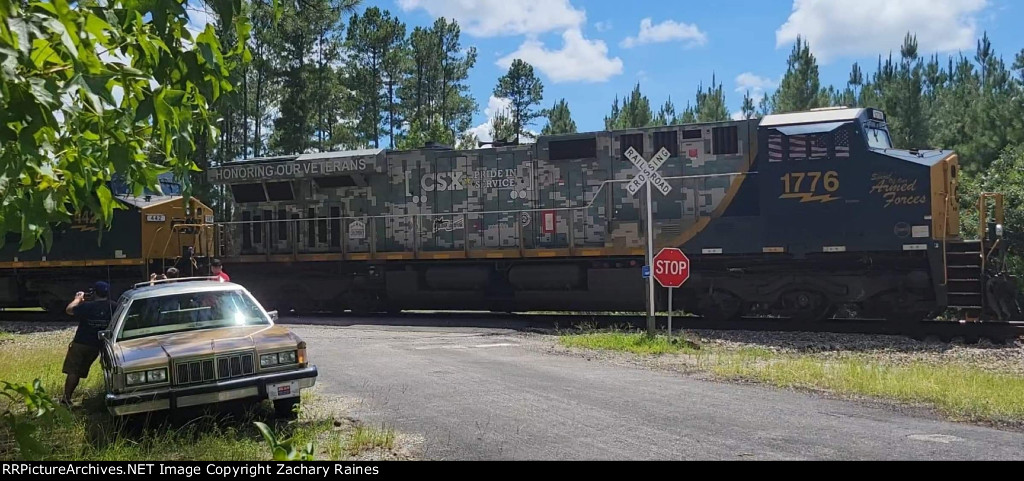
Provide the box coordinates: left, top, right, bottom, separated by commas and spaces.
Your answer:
118, 291, 269, 340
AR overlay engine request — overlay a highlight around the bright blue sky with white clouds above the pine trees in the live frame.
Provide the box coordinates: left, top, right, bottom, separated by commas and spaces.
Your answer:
190, 0, 1024, 140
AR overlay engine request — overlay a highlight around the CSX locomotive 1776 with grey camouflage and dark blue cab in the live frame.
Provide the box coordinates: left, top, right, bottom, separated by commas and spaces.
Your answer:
193, 108, 1020, 320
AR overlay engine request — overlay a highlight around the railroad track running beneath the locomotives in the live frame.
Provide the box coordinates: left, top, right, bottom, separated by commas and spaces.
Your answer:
0, 311, 1024, 344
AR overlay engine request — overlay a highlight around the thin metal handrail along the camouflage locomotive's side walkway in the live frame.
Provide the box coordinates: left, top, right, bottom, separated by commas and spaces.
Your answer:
213, 171, 758, 258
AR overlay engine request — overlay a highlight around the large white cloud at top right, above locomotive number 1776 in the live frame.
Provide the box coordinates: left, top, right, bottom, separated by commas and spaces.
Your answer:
775, 0, 988, 63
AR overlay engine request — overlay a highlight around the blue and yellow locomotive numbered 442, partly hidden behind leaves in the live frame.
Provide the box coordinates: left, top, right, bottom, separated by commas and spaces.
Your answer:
0, 173, 214, 312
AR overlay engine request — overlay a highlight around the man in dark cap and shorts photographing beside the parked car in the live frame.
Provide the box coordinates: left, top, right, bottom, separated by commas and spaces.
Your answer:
60, 280, 116, 406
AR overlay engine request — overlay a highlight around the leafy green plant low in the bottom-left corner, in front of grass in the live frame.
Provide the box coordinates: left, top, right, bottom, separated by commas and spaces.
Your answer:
0, 379, 71, 461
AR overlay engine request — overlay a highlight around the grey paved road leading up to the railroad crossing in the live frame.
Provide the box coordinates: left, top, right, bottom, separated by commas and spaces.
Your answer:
291, 319, 1024, 460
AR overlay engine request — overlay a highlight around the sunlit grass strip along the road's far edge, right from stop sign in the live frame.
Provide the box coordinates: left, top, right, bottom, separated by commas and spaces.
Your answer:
559, 331, 1024, 425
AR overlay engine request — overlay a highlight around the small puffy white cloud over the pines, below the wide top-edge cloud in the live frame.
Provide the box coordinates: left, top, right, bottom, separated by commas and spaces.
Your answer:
498, 29, 623, 84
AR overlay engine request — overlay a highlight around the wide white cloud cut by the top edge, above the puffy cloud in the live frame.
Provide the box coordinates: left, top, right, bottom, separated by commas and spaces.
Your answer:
398, 0, 587, 37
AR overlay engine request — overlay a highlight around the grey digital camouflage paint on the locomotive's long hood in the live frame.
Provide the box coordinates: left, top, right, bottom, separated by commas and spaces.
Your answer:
209, 121, 760, 255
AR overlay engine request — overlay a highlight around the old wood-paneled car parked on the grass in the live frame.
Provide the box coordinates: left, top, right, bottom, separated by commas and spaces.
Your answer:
99, 277, 316, 417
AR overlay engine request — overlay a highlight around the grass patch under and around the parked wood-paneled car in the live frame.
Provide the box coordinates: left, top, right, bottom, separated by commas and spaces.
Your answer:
0, 331, 394, 461
